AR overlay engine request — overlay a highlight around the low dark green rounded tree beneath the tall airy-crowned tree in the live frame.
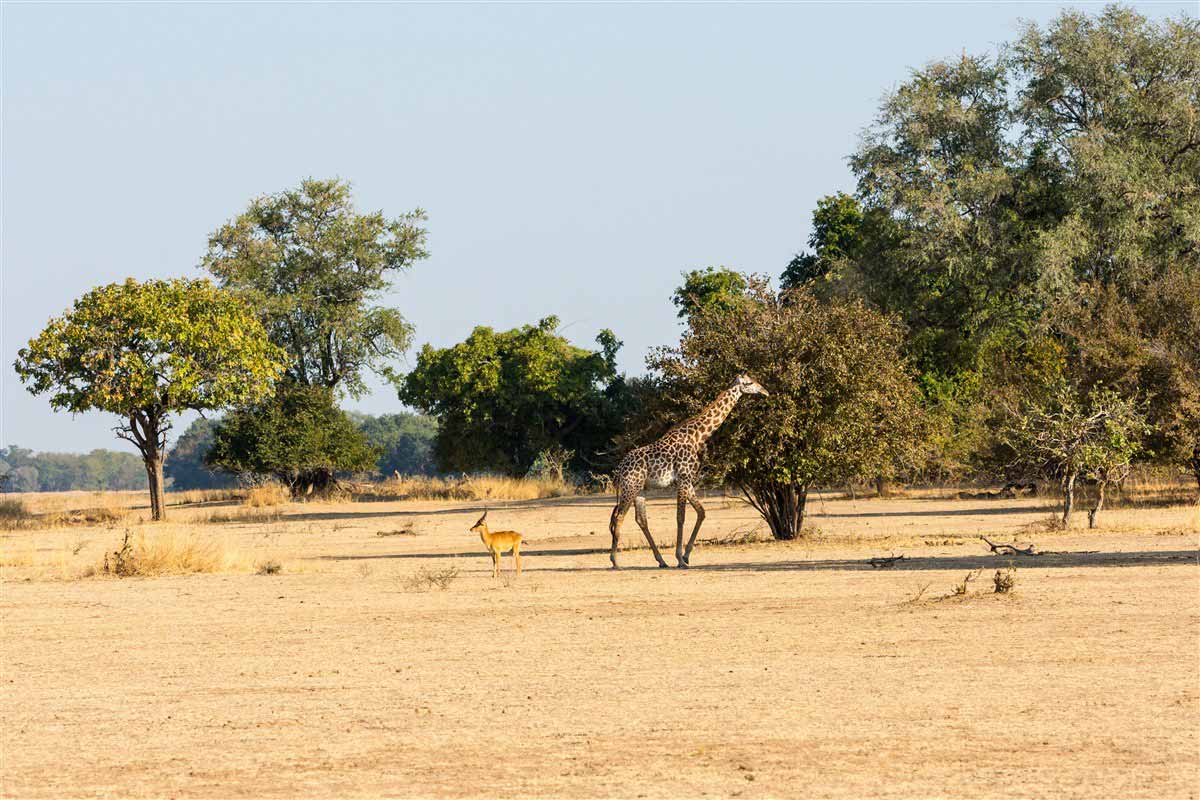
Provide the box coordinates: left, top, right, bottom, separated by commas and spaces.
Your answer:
205, 381, 379, 497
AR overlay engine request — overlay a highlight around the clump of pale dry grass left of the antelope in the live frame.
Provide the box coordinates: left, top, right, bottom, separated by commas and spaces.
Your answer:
100, 530, 253, 577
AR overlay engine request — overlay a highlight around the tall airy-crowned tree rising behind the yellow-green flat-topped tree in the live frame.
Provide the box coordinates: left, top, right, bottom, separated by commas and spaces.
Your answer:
203, 180, 427, 396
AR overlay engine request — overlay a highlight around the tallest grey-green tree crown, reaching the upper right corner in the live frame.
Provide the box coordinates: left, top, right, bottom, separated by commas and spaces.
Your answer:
1012, 6, 1200, 296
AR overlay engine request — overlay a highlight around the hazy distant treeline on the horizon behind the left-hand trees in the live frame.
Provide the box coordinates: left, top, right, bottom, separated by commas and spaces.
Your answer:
0, 413, 437, 492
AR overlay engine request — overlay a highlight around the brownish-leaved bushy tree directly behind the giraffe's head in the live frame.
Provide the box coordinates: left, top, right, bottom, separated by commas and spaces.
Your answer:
647, 278, 920, 540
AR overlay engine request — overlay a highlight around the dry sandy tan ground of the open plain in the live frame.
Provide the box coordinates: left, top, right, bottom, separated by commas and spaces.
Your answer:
0, 498, 1200, 800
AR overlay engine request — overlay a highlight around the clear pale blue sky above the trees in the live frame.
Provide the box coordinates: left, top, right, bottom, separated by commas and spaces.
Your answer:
0, 2, 1196, 451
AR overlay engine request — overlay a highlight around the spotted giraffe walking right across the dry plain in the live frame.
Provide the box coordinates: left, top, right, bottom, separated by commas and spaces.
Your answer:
608, 374, 768, 570
